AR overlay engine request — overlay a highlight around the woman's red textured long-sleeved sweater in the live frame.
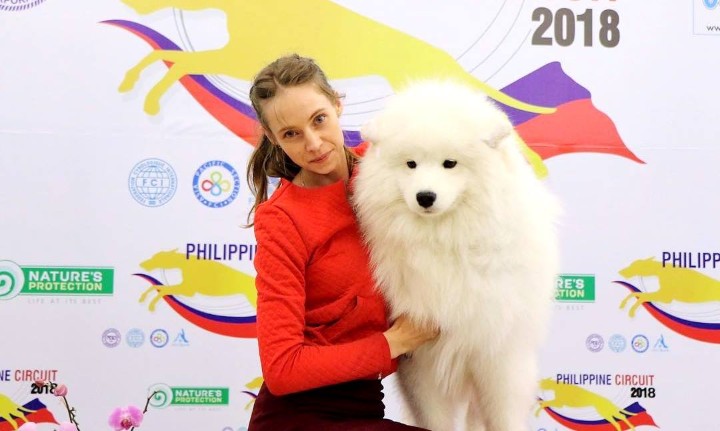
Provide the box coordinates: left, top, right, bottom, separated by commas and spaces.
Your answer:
255, 180, 396, 395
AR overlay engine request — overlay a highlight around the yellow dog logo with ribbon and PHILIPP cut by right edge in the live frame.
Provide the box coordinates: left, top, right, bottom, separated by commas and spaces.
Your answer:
615, 252, 720, 343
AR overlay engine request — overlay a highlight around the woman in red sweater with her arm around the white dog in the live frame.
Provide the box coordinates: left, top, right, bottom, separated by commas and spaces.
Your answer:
248, 55, 437, 431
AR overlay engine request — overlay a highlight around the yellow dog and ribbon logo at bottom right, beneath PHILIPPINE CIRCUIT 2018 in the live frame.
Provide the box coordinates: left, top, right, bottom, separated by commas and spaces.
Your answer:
535, 379, 657, 431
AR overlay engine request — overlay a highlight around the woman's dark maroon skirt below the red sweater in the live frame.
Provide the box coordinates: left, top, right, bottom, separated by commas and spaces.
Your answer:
248, 380, 427, 431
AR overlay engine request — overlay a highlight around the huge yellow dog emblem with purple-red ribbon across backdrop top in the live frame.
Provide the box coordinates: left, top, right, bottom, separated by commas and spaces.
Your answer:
104, 0, 643, 177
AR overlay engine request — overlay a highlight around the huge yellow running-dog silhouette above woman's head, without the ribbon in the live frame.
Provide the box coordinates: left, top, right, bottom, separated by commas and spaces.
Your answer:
119, 0, 555, 115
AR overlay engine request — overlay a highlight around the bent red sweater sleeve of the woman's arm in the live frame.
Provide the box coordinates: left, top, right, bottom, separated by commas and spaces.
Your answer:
250, 206, 394, 395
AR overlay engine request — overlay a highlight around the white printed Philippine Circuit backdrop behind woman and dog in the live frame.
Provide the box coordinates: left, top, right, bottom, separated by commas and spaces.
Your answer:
0, 0, 720, 431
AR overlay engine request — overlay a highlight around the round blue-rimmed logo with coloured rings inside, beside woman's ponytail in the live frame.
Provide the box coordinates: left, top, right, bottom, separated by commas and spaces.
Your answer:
193, 160, 240, 208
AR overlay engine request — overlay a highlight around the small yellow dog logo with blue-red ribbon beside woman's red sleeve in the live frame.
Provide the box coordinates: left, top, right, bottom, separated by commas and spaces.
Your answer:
134, 250, 257, 338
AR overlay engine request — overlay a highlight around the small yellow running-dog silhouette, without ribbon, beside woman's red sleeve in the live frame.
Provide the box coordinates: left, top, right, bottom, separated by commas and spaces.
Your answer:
139, 249, 257, 311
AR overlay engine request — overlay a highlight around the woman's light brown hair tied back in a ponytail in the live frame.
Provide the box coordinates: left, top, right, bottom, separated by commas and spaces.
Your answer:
247, 54, 355, 226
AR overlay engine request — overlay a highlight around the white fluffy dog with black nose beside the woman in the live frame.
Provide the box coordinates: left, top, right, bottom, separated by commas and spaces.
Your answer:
353, 81, 558, 431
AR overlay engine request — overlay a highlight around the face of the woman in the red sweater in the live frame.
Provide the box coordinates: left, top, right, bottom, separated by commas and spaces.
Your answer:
263, 83, 349, 186
